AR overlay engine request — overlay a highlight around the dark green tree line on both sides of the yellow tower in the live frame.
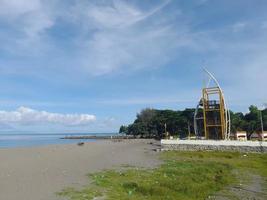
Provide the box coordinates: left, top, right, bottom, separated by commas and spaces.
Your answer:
119, 105, 267, 138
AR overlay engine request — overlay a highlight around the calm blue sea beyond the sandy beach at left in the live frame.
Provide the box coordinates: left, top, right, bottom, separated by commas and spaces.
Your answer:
0, 133, 115, 148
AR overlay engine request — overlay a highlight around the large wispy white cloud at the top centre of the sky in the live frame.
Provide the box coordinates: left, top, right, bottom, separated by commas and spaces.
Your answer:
66, 0, 179, 75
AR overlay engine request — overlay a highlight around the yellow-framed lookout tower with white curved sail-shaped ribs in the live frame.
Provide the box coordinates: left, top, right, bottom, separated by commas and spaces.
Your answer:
194, 69, 230, 140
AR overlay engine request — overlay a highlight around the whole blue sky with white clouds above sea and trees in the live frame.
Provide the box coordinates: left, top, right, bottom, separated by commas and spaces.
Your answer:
0, 0, 267, 133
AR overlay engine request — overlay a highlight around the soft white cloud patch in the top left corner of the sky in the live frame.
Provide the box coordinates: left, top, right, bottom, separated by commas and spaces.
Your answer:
0, 0, 55, 56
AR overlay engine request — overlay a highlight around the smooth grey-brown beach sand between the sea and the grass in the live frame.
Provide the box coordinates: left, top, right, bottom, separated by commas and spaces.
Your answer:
0, 139, 160, 200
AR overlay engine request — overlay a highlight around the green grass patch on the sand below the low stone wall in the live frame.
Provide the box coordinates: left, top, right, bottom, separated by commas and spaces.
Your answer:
59, 151, 267, 200
